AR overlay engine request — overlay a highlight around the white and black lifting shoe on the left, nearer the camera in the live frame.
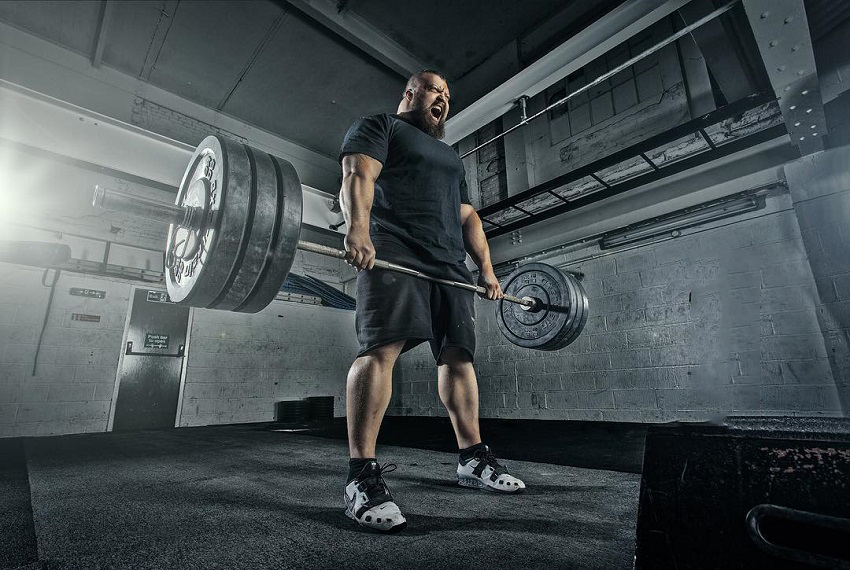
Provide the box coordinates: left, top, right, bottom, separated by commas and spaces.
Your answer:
345, 461, 407, 532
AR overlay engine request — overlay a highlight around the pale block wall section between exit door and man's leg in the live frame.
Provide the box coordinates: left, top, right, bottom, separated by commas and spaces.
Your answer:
179, 301, 357, 426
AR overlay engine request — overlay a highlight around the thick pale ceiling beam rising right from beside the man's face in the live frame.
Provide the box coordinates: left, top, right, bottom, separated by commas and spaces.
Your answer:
444, 0, 688, 144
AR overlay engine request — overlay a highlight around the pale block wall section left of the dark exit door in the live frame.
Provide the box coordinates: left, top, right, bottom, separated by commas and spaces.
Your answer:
0, 264, 131, 437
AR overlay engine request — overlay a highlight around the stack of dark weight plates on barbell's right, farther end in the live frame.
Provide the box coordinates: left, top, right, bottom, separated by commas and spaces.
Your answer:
496, 263, 588, 351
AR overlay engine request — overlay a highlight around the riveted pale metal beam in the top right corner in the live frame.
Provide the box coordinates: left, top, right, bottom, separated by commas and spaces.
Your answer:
744, 0, 827, 155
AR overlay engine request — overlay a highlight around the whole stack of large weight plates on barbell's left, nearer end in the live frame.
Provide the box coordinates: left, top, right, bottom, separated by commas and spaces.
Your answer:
166, 136, 302, 313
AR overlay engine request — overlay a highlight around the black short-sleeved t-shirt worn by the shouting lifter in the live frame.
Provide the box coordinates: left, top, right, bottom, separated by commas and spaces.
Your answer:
339, 114, 469, 278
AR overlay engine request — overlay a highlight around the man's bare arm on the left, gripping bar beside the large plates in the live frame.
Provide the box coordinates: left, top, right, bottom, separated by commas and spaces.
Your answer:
339, 154, 383, 269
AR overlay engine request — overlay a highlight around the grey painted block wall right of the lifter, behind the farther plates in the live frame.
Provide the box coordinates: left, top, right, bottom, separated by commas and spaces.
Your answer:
390, 189, 840, 422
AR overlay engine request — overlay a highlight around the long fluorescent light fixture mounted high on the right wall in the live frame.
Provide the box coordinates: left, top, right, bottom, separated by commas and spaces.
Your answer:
599, 196, 760, 249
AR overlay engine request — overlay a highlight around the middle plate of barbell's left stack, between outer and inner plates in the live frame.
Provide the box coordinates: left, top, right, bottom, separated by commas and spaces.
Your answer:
207, 145, 282, 311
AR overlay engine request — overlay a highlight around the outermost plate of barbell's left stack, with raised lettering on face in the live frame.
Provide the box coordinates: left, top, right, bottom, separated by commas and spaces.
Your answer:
166, 136, 251, 307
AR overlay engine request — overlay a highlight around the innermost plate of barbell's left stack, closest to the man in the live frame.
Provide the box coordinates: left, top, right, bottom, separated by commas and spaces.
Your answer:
234, 151, 303, 313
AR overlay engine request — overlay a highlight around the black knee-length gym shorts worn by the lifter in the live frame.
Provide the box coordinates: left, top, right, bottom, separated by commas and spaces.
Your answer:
355, 261, 475, 361
